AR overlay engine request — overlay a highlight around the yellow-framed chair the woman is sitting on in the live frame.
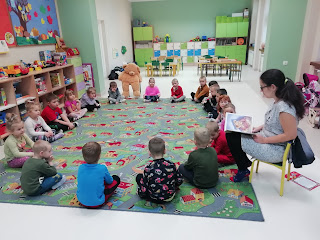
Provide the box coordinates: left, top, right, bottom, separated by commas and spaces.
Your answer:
249, 141, 292, 197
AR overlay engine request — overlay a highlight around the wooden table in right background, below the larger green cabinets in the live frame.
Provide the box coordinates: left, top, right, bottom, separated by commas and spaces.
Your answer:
198, 60, 242, 81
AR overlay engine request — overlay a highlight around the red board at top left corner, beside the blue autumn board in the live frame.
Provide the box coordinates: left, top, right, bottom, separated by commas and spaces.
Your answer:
0, 0, 16, 47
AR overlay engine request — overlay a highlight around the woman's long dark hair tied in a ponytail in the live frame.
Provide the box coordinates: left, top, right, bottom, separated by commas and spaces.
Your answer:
260, 69, 305, 119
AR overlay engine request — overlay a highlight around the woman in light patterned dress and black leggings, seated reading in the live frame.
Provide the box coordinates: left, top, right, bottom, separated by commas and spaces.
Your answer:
226, 69, 305, 182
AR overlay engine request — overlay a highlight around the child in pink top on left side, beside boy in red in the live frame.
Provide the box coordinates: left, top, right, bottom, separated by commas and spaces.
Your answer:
64, 89, 88, 121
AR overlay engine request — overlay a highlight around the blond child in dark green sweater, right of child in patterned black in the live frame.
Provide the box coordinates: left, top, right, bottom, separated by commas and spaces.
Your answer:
179, 128, 219, 188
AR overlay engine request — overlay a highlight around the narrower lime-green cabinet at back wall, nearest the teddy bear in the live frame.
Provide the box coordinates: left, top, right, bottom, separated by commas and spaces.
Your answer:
133, 27, 153, 67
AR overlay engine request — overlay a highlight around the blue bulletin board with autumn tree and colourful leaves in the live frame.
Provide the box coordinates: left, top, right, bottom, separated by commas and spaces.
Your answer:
7, 0, 60, 45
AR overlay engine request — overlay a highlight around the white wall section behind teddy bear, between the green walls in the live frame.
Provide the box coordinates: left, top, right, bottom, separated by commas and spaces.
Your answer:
96, 0, 133, 74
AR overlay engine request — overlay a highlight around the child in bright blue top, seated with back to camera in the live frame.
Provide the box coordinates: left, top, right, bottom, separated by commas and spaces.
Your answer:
77, 142, 120, 208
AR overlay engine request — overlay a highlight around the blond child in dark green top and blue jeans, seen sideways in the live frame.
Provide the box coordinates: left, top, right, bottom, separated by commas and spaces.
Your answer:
20, 140, 66, 196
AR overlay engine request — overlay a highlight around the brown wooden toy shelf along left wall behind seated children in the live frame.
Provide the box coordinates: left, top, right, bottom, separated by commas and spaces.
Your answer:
0, 64, 78, 140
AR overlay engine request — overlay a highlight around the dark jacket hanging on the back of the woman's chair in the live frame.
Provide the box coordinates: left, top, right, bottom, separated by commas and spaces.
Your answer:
290, 128, 315, 168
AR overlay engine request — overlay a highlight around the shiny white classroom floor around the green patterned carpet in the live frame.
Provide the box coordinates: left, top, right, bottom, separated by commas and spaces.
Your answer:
0, 66, 320, 240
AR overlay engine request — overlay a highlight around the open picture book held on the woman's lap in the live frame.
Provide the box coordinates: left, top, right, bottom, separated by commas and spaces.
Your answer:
224, 113, 253, 134
